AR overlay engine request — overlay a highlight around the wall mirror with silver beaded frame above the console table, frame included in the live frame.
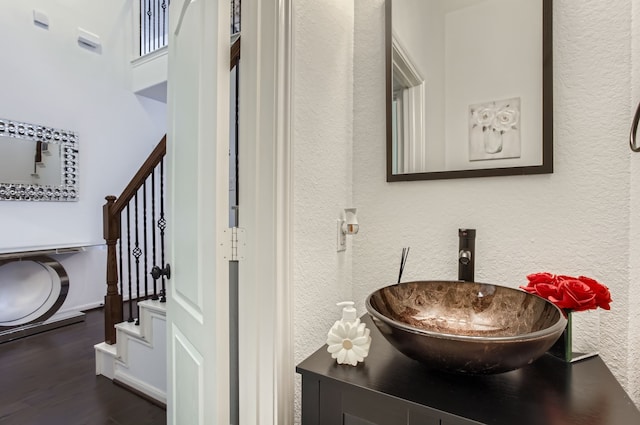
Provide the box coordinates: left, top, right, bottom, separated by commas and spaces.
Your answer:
0, 118, 78, 201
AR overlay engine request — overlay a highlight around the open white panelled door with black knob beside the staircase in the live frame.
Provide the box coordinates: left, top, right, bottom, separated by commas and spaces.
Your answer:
167, 0, 229, 425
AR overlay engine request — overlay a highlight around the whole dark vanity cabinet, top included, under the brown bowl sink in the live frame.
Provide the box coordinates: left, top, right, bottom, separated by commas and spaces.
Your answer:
297, 317, 640, 425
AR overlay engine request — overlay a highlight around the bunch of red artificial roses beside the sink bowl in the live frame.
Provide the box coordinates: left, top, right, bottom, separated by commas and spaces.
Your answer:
520, 272, 611, 311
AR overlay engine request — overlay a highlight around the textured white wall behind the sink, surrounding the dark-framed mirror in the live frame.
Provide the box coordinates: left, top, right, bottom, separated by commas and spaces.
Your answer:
352, 0, 640, 404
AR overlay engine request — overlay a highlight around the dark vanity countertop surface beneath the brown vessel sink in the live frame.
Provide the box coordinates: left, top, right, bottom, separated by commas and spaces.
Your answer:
296, 315, 640, 425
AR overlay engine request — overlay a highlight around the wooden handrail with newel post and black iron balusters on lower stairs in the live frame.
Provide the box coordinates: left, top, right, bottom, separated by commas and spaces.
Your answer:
102, 136, 168, 344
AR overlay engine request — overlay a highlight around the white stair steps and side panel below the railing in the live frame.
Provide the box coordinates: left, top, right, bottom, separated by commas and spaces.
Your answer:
94, 300, 167, 406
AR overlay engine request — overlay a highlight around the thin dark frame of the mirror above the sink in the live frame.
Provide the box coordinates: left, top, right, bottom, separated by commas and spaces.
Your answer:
385, 0, 553, 182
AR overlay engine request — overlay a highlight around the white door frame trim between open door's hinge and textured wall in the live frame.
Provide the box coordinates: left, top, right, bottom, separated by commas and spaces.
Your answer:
238, 0, 295, 425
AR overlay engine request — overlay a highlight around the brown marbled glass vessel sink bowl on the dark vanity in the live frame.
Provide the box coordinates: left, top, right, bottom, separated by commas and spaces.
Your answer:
366, 281, 567, 374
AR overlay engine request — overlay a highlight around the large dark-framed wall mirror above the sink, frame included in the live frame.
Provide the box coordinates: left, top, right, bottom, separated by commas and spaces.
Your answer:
385, 0, 553, 182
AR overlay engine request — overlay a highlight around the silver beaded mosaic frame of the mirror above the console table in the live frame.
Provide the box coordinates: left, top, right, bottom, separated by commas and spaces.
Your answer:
0, 118, 79, 201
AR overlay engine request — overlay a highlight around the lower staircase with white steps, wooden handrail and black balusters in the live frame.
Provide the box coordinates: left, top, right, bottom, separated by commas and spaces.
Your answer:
94, 137, 170, 406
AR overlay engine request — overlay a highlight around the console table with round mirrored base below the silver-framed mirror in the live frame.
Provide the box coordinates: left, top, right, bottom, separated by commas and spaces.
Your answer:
0, 246, 84, 342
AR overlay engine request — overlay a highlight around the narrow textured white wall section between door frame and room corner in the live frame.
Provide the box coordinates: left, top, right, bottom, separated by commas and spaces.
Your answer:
293, 0, 354, 414
